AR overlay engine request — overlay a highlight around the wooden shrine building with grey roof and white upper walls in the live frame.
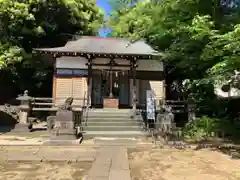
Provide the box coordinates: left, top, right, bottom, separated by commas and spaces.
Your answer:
34, 36, 165, 108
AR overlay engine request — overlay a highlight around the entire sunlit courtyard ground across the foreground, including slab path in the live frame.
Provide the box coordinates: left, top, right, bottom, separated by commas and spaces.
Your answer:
0, 136, 240, 180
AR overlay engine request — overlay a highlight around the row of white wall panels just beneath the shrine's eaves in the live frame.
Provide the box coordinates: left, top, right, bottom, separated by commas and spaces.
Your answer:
56, 56, 163, 71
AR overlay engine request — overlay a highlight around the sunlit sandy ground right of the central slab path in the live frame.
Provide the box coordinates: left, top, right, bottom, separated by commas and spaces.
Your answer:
129, 148, 240, 180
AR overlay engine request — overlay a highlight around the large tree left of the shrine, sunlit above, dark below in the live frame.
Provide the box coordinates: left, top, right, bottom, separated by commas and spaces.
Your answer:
0, 0, 104, 99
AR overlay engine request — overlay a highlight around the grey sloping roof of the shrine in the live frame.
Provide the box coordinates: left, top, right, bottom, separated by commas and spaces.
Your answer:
35, 36, 161, 55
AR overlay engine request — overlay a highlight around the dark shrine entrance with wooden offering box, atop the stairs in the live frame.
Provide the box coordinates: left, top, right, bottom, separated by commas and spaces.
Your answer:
91, 69, 130, 108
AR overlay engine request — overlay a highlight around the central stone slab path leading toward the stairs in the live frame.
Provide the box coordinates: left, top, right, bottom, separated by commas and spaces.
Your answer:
87, 147, 131, 180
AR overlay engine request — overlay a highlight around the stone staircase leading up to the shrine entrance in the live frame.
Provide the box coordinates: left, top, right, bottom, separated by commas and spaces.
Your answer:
84, 108, 144, 138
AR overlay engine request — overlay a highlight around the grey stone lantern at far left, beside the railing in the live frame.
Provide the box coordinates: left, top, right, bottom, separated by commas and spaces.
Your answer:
16, 90, 32, 124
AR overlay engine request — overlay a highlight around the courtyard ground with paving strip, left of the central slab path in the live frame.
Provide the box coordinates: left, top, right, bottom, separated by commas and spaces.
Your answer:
0, 146, 97, 180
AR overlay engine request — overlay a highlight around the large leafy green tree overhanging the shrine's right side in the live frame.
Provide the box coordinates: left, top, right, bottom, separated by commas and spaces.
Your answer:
107, 0, 240, 118
